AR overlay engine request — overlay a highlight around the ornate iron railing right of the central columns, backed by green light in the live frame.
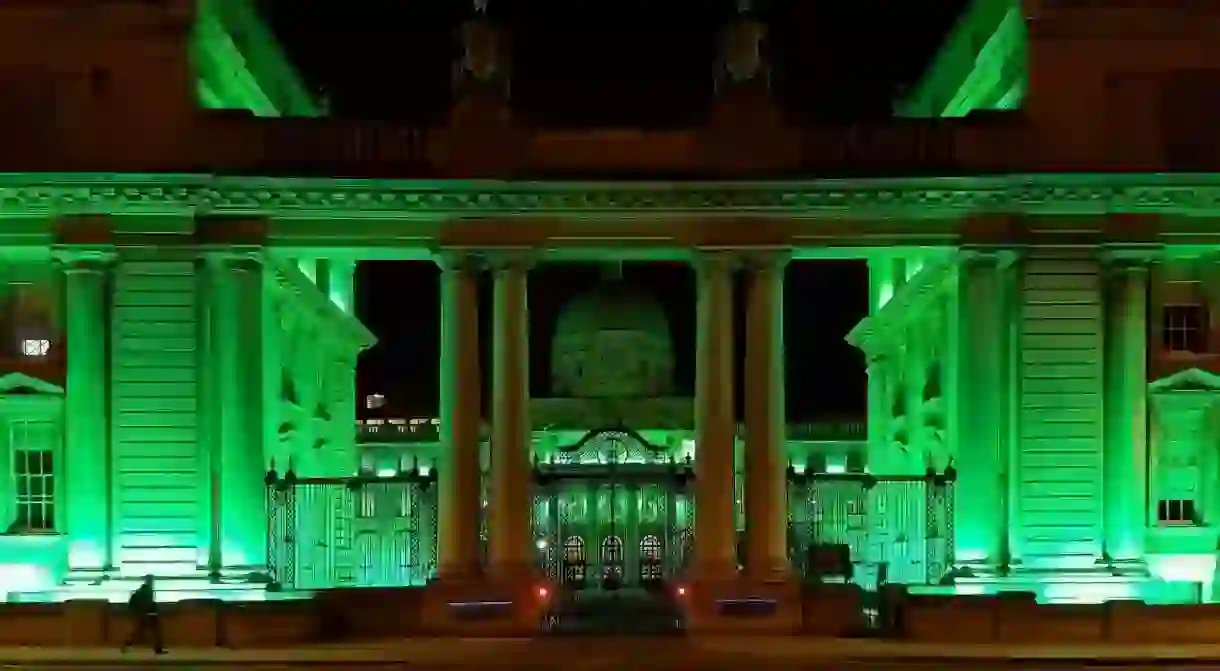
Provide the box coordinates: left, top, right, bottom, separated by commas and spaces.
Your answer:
788, 467, 956, 589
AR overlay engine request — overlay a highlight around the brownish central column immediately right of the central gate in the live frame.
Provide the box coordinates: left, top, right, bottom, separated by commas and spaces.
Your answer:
694, 251, 737, 582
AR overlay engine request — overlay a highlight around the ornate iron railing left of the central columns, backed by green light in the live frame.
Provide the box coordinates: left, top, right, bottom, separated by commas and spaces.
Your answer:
266, 471, 437, 590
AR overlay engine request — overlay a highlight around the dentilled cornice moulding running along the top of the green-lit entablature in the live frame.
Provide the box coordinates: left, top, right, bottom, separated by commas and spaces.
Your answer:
0, 173, 1220, 220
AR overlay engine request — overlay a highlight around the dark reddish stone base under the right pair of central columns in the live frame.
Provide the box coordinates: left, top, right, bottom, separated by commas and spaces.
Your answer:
678, 577, 803, 636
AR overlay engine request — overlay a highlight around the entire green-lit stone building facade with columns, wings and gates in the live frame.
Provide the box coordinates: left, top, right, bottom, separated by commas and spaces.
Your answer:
0, 0, 1220, 614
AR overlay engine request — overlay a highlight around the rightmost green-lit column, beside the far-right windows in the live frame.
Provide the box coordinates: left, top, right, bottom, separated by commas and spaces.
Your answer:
1102, 262, 1148, 572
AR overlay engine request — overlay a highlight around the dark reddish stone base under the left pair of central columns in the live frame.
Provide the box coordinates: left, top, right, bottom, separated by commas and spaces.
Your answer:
422, 571, 555, 637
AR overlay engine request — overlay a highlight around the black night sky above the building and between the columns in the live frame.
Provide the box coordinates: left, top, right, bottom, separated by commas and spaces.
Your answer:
259, 0, 966, 421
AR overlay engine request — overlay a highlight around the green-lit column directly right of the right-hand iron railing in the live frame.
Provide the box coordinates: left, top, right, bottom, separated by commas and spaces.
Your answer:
944, 251, 1014, 572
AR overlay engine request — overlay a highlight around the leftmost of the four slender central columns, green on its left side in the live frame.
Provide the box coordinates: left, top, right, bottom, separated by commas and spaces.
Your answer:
437, 253, 482, 582
